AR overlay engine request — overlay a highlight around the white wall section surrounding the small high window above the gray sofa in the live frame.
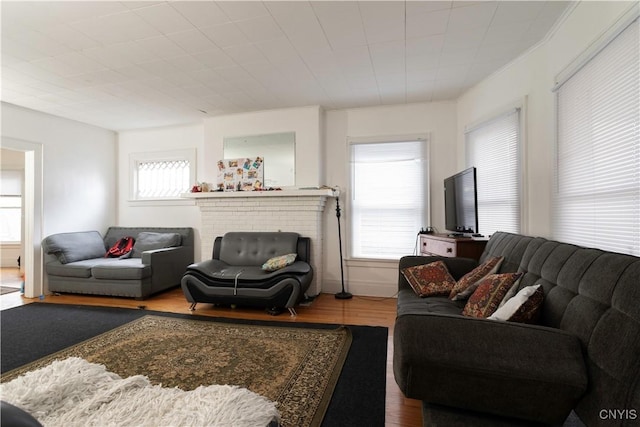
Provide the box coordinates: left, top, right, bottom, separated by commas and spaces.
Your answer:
118, 123, 202, 260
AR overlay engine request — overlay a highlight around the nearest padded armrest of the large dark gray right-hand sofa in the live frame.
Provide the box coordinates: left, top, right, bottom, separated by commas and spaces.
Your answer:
393, 314, 587, 423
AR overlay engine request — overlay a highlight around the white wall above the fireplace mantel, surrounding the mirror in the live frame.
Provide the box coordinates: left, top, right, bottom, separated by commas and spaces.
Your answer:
202, 106, 324, 187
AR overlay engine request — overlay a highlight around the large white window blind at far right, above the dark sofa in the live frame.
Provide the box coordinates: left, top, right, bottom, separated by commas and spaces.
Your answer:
553, 19, 640, 255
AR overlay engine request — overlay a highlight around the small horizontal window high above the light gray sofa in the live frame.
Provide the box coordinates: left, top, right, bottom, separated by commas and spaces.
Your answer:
131, 150, 196, 200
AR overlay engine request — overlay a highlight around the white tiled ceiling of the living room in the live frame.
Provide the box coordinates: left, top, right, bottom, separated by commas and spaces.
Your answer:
0, 0, 571, 130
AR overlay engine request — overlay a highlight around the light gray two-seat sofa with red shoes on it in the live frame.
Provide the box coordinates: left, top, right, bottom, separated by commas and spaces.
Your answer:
42, 227, 194, 299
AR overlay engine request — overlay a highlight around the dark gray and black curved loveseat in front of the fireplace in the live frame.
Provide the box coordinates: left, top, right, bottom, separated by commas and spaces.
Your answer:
182, 232, 313, 315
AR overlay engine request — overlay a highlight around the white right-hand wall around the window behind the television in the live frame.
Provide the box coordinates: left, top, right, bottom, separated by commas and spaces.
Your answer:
457, 1, 637, 237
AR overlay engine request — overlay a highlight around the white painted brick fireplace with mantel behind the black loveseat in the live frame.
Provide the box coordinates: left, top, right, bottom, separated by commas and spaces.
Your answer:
183, 189, 335, 295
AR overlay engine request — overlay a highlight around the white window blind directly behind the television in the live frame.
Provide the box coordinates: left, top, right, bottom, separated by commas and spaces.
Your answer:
465, 108, 521, 235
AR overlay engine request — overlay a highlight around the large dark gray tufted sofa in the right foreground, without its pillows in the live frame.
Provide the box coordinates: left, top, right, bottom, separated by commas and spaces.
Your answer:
393, 232, 640, 427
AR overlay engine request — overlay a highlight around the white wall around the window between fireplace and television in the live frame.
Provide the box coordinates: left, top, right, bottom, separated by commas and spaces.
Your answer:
323, 102, 458, 296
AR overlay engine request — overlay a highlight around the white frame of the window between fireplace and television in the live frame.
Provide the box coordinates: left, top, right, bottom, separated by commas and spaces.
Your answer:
345, 133, 431, 265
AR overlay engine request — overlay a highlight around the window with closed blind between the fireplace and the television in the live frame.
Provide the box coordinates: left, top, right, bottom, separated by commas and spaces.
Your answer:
350, 138, 429, 259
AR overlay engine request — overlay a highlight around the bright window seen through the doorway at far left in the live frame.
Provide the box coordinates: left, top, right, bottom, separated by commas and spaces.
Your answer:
0, 170, 23, 243
